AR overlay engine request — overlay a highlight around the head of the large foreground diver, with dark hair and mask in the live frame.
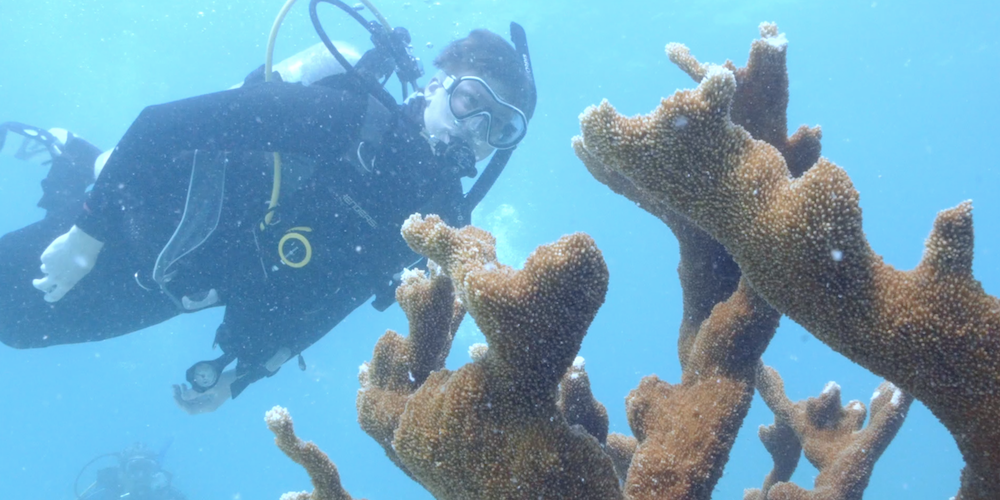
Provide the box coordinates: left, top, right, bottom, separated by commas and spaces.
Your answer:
424, 29, 535, 160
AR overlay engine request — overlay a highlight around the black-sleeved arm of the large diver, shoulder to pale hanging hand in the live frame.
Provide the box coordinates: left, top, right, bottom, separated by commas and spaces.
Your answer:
77, 83, 368, 241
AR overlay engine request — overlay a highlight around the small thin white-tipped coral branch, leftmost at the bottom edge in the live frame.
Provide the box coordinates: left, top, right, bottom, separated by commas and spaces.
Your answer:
264, 406, 360, 500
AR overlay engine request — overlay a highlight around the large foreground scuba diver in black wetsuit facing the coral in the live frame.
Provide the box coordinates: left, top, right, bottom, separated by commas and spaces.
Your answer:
0, 0, 536, 413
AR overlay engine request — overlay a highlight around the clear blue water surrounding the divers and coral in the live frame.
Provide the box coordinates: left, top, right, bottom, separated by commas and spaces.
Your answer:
0, 0, 1000, 500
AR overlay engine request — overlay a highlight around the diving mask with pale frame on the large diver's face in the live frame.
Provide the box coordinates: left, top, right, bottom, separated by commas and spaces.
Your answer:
442, 76, 528, 149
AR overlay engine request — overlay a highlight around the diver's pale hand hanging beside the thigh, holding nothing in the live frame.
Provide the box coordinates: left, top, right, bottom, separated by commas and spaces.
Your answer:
31, 226, 104, 302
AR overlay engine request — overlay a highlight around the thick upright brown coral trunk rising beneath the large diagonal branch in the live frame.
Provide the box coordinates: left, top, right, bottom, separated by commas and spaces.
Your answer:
625, 281, 780, 499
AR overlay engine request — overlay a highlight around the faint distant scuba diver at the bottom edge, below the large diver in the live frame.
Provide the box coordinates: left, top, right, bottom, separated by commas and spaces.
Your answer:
73, 443, 186, 500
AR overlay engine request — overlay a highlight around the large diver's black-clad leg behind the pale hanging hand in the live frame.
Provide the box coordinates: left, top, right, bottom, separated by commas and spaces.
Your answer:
0, 216, 178, 348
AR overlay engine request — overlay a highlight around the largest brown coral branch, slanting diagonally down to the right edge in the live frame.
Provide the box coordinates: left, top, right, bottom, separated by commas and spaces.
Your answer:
577, 24, 1000, 498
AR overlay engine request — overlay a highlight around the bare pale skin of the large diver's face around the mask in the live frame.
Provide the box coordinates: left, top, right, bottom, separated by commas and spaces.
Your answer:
424, 73, 496, 161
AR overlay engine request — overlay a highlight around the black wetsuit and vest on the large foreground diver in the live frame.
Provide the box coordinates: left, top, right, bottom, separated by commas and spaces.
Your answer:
0, 77, 474, 395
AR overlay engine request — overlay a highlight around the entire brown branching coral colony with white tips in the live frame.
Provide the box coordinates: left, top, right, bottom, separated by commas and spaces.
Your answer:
267, 23, 1000, 500
